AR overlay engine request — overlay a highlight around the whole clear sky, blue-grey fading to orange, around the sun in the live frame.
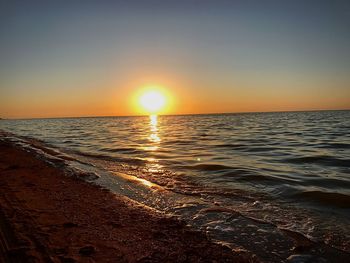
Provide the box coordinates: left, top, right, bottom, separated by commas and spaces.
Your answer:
0, 0, 350, 118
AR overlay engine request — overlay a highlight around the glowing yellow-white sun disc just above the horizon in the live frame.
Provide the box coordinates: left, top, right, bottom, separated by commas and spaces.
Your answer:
139, 90, 167, 114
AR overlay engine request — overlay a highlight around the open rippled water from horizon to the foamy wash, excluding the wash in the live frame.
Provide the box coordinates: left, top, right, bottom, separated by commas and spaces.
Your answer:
0, 111, 350, 260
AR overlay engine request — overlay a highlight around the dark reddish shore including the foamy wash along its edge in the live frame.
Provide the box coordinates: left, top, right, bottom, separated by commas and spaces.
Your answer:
0, 133, 349, 263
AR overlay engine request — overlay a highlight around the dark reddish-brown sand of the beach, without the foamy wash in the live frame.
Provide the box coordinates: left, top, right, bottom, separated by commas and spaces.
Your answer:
0, 140, 257, 263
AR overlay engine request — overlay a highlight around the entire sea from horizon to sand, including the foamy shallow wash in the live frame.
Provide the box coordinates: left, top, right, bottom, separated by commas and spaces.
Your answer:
0, 111, 350, 262
